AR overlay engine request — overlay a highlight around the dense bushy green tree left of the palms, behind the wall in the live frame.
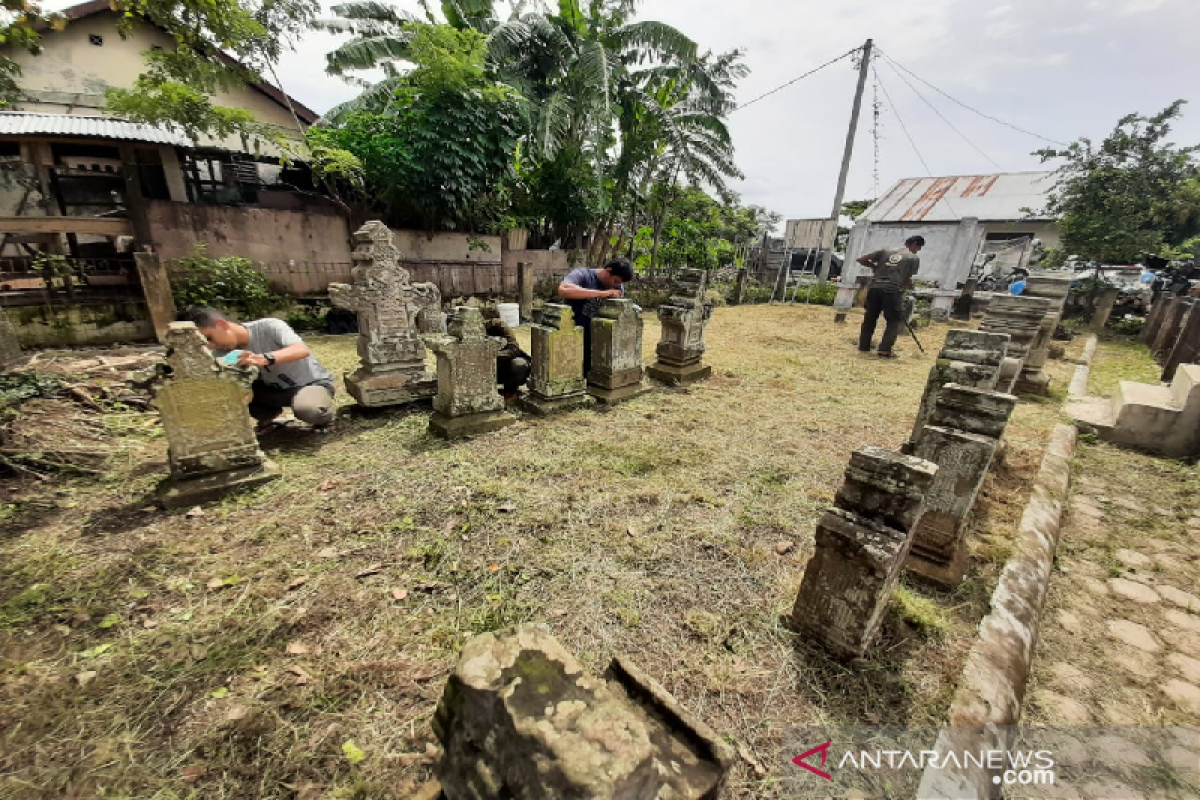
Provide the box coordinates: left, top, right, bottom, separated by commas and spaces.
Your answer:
308, 25, 523, 230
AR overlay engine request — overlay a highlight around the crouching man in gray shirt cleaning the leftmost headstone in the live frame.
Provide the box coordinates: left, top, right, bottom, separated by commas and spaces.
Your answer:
179, 307, 334, 432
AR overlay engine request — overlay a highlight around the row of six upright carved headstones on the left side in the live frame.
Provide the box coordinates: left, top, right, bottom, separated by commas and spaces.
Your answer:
150, 222, 710, 507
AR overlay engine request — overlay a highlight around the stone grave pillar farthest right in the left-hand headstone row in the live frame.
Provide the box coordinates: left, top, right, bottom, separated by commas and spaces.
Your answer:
646, 270, 713, 386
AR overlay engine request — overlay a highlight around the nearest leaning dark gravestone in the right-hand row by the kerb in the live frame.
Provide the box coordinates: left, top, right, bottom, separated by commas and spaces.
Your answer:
791, 447, 937, 658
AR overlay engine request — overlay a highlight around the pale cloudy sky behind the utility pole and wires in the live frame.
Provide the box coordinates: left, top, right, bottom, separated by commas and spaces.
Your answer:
48, 0, 1200, 218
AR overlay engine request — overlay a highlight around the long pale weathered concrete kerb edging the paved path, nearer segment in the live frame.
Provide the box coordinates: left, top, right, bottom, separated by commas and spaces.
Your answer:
917, 425, 1076, 798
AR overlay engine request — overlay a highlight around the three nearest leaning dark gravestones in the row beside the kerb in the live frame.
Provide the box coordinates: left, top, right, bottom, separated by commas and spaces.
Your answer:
791, 328, 1017, 658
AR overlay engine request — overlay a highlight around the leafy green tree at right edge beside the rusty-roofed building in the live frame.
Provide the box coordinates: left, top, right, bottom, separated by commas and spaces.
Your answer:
1036, 101, 1200, 264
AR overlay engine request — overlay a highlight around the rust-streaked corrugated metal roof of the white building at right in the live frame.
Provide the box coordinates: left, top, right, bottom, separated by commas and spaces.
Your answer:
858, 173, 1055, 222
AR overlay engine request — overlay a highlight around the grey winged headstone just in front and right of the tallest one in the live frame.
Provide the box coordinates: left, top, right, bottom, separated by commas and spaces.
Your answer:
430, 306, 516, 439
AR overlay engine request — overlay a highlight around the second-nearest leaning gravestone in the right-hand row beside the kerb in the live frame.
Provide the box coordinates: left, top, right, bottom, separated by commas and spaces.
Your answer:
905, 384, 1016, 588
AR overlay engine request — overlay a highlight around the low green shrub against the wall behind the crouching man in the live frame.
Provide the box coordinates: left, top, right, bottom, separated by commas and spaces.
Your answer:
170, 243, 283, 319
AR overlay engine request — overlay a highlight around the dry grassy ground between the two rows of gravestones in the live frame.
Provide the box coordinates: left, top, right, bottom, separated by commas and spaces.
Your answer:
0, 306, 1069, 799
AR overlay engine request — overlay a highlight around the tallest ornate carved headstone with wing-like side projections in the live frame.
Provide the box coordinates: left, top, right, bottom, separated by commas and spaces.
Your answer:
329, 221, 440, 408
